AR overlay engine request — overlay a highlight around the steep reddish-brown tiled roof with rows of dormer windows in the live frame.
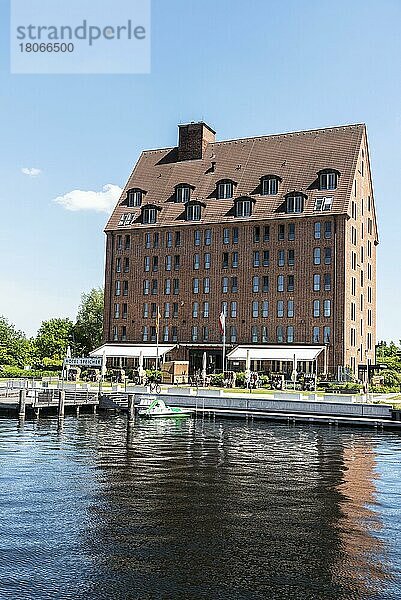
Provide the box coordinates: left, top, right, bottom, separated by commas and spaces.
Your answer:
106, 124, 365, 231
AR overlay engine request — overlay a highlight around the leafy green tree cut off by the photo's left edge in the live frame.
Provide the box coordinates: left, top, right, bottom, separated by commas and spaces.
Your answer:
0, 316, 34, 367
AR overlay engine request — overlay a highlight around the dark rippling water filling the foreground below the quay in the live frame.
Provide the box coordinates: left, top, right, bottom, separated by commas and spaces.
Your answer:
0, 416, 401, 600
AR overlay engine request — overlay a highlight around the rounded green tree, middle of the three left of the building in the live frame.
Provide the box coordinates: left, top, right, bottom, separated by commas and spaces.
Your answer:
35, 318, 74, 360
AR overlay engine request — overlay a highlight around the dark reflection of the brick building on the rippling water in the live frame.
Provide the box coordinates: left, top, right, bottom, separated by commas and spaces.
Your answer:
76, 420, 387, 600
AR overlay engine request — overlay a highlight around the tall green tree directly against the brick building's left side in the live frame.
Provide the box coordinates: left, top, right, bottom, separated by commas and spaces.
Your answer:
74, 288, 104, 355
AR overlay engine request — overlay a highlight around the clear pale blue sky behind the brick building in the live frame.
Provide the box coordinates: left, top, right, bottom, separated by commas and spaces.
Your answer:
0, 0, 401, 340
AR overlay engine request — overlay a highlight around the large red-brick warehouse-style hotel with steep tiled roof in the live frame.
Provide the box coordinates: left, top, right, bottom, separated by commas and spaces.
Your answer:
104, 122, 378, 373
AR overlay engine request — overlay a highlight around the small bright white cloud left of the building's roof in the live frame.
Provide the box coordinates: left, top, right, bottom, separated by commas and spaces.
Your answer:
53, 183, 122, 213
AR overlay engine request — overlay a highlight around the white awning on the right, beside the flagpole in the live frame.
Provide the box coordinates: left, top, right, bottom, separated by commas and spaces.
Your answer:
227, 345, 325, 362
